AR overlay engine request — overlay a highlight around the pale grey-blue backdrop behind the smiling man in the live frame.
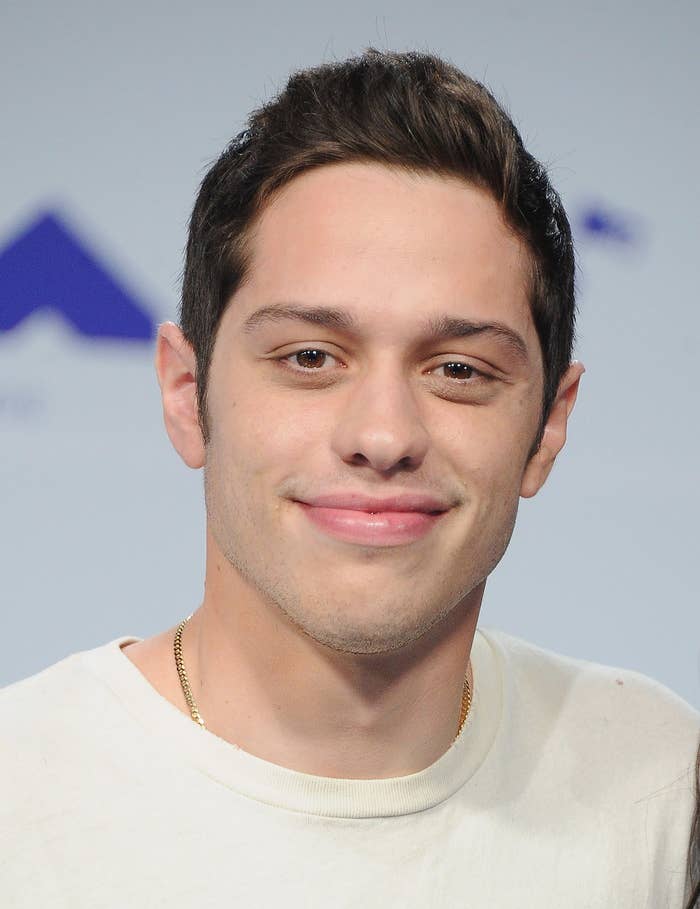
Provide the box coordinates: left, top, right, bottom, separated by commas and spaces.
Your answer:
0, 0, 700, 707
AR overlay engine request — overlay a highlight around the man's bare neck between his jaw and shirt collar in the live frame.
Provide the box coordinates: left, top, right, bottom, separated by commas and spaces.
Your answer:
182, 544, 484, 779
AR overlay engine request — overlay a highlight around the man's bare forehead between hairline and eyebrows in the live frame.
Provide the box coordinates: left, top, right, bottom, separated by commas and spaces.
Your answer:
231, 163, 537, 344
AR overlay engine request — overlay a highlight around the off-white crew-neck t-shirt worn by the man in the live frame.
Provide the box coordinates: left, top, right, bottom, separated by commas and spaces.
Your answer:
0, 629, 700, 909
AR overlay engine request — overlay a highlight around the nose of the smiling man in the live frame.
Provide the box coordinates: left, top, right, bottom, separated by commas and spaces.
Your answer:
332, 364, 429, 473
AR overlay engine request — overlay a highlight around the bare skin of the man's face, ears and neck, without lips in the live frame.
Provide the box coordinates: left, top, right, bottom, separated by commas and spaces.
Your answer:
124, 164, 583, 778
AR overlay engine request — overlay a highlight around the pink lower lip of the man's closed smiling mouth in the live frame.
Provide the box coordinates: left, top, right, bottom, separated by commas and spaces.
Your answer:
297, 502, 445, 546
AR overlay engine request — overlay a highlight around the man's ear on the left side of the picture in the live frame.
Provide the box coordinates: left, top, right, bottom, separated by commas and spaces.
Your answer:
155, 322, 205, 468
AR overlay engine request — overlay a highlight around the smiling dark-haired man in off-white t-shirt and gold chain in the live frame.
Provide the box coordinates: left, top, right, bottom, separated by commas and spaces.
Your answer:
0, 50, 699, 909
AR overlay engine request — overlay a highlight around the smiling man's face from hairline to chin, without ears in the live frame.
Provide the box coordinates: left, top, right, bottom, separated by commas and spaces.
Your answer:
205, 164, 543, 652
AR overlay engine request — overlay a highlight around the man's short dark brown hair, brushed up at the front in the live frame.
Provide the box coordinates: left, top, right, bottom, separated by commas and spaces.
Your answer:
180, 48, 575, 445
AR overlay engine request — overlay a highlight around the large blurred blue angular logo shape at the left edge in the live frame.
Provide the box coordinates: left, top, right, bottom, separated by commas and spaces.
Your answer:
0, 212, 155, 341
